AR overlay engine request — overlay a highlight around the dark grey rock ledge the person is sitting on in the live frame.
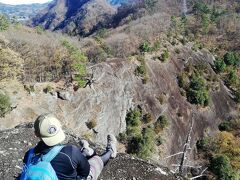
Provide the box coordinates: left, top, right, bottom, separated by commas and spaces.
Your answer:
0, 124, 176, 180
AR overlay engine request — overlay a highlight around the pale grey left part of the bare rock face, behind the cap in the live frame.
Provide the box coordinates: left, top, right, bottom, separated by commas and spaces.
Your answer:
1, 60, 137, 142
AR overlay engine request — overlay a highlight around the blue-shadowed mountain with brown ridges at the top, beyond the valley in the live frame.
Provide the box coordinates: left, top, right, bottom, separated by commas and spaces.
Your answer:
32, 0, 117, 36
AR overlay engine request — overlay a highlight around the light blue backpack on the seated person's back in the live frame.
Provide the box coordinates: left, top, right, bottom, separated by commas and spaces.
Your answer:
20, 146, 64, 180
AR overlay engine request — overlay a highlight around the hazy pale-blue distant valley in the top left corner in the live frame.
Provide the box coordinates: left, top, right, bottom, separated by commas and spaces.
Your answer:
0, 3, 48, 20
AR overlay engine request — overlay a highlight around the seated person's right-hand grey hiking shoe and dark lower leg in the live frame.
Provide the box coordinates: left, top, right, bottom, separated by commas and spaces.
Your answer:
100, 135, 117, 165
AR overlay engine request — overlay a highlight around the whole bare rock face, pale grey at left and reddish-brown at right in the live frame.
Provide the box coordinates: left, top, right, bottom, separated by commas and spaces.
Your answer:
1, 45, 236, 165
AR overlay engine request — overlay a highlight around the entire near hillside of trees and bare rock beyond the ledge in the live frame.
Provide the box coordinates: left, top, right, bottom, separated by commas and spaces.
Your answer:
0, 0, 240, 179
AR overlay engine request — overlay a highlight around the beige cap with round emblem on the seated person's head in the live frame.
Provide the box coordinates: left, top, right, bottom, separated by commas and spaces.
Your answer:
34, 114, 65, 146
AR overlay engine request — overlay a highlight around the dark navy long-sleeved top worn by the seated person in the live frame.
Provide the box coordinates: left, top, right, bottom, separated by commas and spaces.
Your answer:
23, 141, 90, 180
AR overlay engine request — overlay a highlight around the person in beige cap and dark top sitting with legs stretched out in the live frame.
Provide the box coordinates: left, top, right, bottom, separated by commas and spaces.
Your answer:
20, 114, 117, 180
